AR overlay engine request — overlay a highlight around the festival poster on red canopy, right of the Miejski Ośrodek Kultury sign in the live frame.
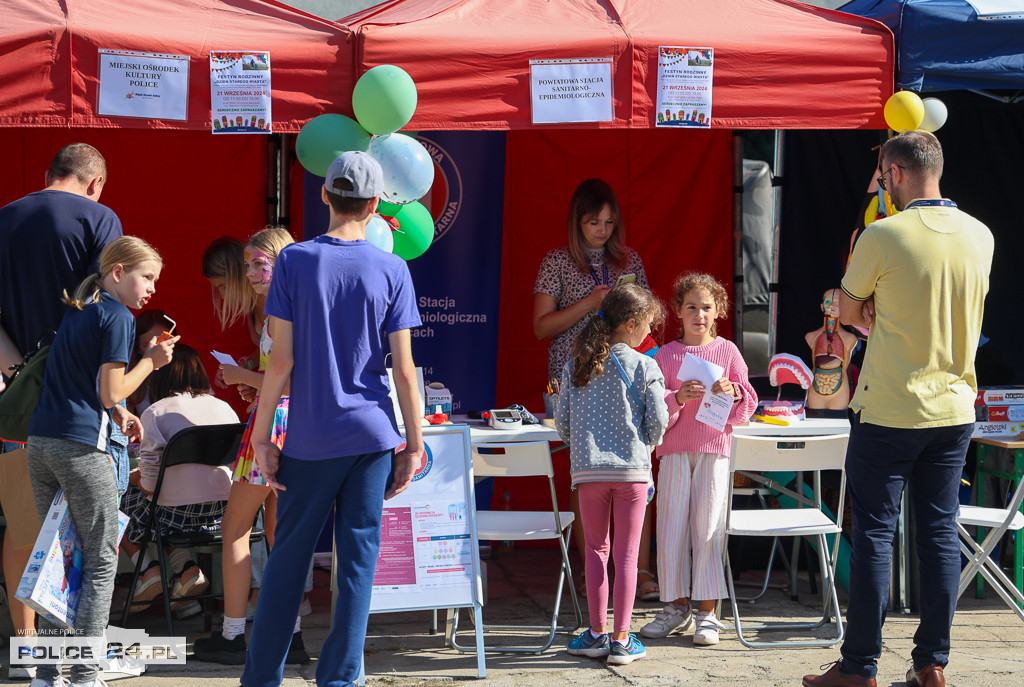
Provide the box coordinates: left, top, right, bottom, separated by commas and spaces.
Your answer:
210, 50, 272, 133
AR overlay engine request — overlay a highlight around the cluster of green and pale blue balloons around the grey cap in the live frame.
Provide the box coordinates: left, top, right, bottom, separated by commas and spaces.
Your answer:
295, 65, 434, 260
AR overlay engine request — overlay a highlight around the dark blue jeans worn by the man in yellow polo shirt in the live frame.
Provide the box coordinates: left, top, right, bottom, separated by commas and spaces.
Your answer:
840, 415, 974, 678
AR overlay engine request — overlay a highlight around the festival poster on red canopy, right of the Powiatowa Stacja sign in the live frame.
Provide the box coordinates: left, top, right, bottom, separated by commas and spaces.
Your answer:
654, 45, 715, 129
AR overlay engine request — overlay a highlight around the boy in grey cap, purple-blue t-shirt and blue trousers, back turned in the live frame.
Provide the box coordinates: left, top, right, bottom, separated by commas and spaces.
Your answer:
242, 152, 423, 687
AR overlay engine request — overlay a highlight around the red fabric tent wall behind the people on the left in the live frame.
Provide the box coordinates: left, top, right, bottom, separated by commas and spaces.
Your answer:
0, 128, 301, 413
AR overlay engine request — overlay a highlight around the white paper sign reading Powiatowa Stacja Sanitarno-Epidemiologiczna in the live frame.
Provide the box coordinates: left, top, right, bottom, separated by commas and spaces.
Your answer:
529, 57, 614, 124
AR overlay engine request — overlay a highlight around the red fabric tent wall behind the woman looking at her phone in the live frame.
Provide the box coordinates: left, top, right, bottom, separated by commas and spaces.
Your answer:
498, 129, 732, 415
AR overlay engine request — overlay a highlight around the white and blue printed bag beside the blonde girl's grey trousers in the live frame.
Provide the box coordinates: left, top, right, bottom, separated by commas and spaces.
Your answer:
14, 489, 128, 630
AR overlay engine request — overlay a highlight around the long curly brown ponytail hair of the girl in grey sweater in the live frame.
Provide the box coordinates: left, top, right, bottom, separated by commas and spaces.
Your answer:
572, 284, 665, 387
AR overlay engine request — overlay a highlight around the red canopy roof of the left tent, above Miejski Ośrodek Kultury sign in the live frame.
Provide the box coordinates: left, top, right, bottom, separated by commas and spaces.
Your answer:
0, 0, 353, 132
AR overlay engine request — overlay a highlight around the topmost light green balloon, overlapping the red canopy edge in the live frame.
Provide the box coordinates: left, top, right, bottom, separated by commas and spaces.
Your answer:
352, 65, 416, 136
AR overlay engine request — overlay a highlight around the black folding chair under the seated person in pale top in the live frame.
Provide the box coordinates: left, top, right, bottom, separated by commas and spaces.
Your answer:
121, 423, 265, 637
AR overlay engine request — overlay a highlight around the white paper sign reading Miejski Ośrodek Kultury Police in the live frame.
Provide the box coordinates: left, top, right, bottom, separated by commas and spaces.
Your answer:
96, 50, 188, 121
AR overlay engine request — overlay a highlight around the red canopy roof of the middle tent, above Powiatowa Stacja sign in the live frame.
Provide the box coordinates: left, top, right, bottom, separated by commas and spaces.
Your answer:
341, 0, 894, 130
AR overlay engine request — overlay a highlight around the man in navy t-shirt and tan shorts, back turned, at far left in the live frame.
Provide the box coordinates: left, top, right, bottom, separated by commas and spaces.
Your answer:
0, 143, 122, 678
